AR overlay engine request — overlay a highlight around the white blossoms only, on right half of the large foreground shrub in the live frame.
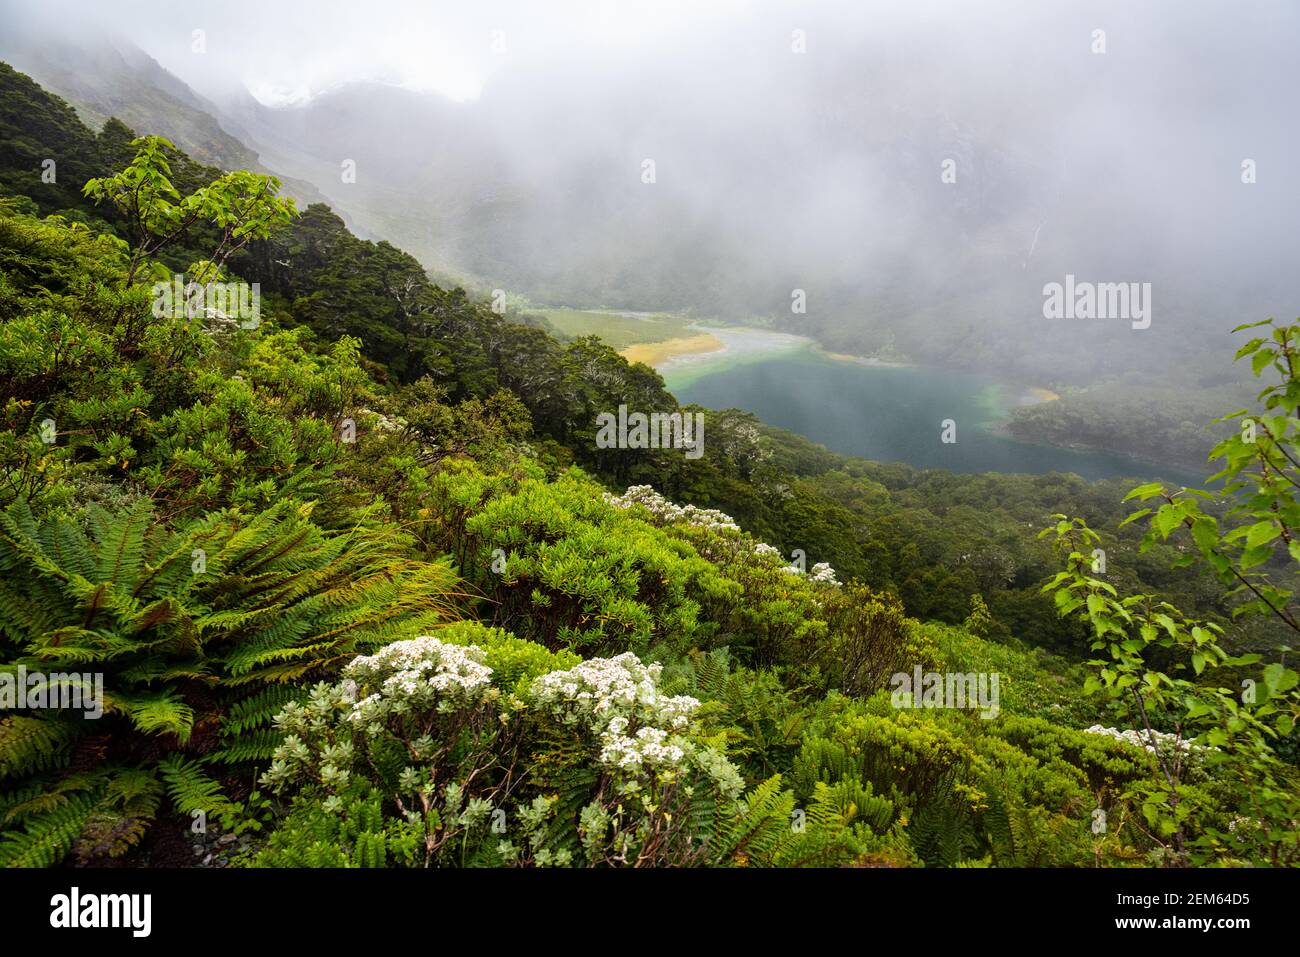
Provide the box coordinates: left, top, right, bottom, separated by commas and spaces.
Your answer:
532, 651, 744, 797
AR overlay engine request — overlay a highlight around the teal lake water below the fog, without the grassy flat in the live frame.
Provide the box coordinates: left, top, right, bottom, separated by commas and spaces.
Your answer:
660, 347, 1208, 484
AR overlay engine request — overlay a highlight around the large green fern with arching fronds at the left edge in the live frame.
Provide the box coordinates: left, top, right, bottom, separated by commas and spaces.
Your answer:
0, 503, 452, 859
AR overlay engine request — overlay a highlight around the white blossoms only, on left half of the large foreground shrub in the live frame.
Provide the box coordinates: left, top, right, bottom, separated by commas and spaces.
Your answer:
343, 635, 491, 726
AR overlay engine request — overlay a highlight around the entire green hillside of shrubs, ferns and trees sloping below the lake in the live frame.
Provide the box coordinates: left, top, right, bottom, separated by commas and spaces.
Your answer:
0, 55, 1300, 867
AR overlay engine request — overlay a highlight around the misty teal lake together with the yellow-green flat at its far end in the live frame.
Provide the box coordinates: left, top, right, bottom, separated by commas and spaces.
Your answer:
537, 309, 1204, 485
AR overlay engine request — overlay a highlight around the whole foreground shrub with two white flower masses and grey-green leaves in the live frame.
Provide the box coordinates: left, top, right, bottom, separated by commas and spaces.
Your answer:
254, 623, 744, 866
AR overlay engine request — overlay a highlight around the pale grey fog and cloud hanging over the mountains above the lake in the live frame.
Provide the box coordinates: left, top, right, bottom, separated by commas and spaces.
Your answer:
0, 0, 1300, 382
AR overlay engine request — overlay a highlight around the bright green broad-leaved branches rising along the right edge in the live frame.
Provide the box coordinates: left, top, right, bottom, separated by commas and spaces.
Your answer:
1043, 320, 1300, 865
